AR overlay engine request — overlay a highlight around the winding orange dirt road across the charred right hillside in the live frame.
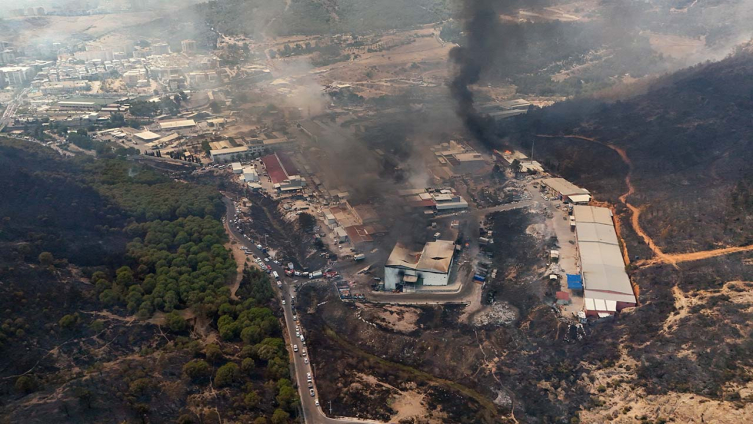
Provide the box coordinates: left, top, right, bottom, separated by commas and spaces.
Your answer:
536, 134, 753, 268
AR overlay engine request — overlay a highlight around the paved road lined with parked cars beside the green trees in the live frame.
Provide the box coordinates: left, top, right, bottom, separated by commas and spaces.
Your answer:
223, 197, 378, 424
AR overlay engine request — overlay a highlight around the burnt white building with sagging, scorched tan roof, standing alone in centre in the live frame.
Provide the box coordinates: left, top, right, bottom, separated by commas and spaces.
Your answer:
384, 240, 455, 290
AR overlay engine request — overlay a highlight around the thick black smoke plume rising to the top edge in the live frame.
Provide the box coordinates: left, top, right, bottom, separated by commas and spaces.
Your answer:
450, 0, 545, 147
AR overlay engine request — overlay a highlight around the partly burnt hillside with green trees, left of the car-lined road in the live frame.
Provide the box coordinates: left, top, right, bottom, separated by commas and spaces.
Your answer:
0, 139, 298, 423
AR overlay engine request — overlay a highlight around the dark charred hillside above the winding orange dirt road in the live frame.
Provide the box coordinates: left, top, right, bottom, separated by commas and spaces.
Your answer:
508, 52, 753, 253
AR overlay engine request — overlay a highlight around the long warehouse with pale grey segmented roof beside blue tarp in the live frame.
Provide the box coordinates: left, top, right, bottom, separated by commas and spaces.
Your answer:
573, 206, 636, 317
